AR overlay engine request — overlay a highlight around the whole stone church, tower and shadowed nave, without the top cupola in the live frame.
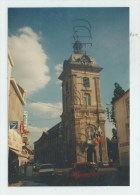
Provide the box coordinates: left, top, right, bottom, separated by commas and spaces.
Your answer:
34, 45, 108, 166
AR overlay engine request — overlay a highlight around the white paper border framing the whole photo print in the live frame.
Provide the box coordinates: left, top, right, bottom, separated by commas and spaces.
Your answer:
0, 0, 140, 195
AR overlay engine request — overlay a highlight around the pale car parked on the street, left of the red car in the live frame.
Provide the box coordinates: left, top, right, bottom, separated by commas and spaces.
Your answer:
38, 164, 55, 178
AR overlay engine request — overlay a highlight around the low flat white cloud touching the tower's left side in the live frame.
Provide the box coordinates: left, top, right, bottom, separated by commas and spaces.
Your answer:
28, 102, 62, 118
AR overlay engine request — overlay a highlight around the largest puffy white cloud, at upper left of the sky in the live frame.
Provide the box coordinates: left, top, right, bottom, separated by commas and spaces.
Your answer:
8, 27, 50, 93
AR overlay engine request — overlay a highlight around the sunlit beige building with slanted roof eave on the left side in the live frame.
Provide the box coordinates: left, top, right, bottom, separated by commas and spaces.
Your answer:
8, 78, 28, 166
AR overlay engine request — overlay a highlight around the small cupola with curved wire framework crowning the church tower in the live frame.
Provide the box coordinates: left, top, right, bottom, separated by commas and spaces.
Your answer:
73, 19, 92, 54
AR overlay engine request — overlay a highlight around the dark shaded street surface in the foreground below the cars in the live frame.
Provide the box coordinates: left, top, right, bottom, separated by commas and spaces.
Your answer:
9, 168, 129, 186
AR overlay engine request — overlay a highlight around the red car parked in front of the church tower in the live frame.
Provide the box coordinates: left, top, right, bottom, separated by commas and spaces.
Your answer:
71, 162, 100, 181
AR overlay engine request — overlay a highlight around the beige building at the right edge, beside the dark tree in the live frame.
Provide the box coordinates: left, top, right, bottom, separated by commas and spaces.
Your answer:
114, 90, 130, 166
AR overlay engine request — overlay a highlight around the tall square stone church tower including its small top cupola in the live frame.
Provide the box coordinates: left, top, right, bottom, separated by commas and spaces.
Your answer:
59, 22, 108, 163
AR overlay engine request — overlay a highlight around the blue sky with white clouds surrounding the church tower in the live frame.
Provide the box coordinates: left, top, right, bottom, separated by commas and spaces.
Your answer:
8, 8, 129, 148
